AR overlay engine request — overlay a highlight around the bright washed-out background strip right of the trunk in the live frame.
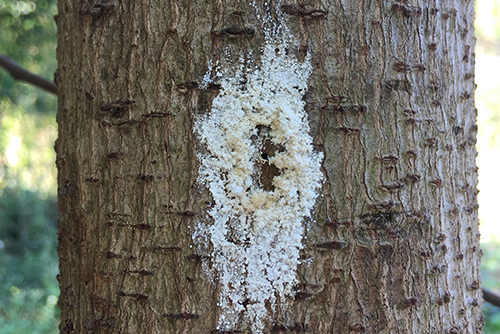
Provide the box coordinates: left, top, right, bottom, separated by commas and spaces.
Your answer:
475, 0, 500, 334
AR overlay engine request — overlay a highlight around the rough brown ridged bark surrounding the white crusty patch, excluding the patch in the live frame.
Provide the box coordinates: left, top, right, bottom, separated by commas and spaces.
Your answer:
56, 0, 483, 334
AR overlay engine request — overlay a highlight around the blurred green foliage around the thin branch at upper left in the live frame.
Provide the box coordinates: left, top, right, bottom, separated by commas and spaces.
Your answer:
0, 0, 57, 115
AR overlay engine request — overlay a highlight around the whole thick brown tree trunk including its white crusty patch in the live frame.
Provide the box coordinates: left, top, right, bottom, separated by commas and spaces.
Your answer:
56, 0, 483, 334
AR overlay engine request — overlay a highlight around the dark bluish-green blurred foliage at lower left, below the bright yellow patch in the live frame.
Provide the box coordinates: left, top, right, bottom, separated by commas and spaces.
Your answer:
0, 187, 59, 334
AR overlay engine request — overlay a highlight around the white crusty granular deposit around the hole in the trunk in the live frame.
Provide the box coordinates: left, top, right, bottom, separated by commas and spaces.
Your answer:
196, 3, 322, 333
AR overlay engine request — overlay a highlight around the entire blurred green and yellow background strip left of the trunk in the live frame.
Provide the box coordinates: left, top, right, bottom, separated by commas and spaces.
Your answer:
0, 0, 59, 334
